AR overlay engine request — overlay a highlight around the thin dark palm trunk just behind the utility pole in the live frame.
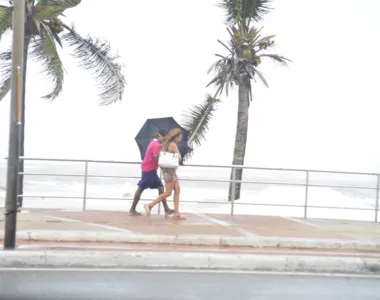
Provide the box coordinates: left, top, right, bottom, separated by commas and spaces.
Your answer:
17, 35, 31, 208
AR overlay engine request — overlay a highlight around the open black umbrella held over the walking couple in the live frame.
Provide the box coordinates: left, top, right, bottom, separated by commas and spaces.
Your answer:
135, 117, 193, 160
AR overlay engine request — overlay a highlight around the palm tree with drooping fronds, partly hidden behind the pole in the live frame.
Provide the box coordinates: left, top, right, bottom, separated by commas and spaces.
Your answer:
0, 0, 125, 207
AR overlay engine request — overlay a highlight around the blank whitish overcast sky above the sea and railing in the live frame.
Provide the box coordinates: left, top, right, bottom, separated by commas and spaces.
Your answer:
0, 0, 380, 172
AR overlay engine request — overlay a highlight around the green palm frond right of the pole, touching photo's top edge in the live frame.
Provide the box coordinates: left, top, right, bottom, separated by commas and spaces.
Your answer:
35, 0, 82, 21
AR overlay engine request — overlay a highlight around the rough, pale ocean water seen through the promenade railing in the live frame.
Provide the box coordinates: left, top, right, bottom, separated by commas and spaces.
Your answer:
0, 161, 376, 221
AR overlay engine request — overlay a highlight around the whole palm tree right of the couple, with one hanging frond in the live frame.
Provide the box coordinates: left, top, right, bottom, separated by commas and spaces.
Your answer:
179, 0, 284, 200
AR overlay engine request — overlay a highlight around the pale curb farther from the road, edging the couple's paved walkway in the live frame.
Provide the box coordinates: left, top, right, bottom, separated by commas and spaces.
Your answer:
0, 230, 380, 251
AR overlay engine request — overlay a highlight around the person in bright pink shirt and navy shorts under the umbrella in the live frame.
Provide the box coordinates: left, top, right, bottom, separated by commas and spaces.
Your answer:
129, 130, 174, 216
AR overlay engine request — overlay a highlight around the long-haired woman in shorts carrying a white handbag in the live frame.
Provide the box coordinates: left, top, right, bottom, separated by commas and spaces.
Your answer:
144, 128, 185, 220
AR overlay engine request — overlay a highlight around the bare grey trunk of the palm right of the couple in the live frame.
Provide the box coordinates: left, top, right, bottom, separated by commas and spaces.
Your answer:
228, 84, 249, 201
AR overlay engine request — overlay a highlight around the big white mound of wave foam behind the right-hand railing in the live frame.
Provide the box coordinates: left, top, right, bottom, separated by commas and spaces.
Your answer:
199, 186, 375, 221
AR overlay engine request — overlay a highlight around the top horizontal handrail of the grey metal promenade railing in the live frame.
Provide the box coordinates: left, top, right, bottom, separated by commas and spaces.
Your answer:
6, 156, 380, 176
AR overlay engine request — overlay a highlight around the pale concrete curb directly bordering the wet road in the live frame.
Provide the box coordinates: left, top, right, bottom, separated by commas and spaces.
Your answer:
0, 251, 380, 274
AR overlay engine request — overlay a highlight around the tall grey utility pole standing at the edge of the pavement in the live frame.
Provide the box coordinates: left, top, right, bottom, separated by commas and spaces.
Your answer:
4, 0, 25, 249
